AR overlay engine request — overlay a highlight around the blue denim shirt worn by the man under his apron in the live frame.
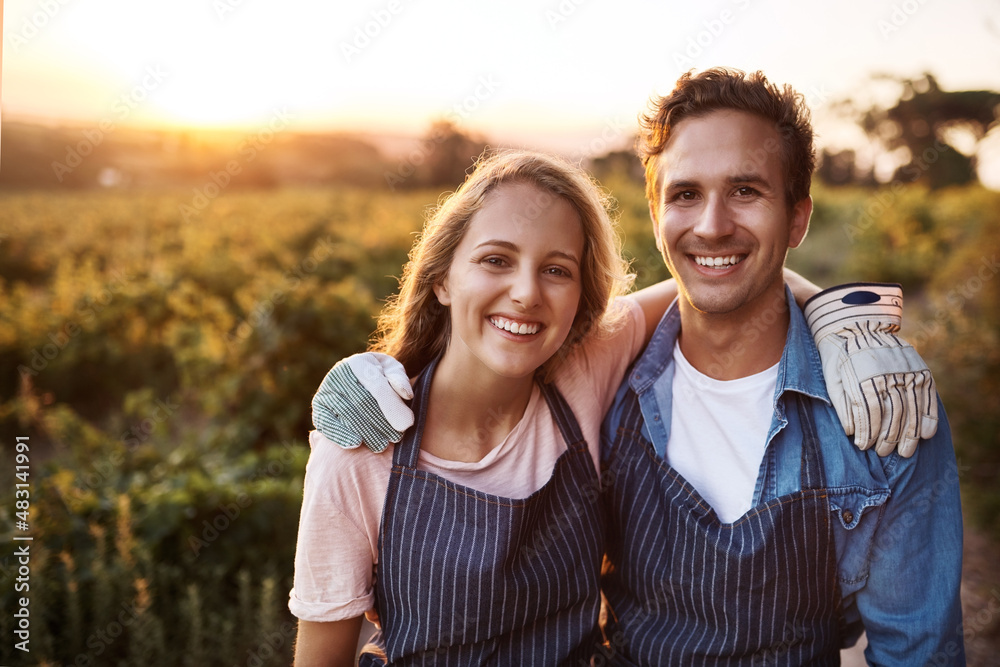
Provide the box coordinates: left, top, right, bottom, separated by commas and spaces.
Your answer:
602, 292, 965, 665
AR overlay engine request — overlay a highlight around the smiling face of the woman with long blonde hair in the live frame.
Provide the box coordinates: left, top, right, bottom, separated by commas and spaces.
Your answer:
434, 183, 583, 378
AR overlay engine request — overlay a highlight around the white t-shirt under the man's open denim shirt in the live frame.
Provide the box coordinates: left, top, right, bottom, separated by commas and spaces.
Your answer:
667, 343, 778, 523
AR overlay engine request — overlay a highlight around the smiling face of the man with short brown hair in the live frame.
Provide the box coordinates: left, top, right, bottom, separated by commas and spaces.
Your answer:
650, 110, 812, 315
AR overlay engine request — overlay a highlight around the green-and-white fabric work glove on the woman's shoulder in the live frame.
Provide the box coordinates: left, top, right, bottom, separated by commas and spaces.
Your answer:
312, 352, 413, 453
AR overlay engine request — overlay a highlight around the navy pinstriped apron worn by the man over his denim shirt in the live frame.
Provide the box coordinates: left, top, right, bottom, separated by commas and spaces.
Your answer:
602, 394, 840, 665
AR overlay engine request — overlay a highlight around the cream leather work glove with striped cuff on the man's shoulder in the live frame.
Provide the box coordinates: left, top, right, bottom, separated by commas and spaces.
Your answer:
803, 283, 938, 457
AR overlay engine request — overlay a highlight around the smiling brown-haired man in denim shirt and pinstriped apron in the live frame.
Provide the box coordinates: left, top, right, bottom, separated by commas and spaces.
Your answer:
602, 69, 964, 665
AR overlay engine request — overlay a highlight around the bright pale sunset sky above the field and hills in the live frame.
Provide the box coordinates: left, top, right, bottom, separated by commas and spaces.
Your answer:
2, 0, 1000, 180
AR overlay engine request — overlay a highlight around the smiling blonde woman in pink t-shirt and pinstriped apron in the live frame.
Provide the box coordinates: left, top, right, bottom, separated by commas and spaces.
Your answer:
290, 152, 673, 665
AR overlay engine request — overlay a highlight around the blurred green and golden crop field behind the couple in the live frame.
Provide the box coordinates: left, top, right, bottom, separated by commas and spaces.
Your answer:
0, 177, 1000, 665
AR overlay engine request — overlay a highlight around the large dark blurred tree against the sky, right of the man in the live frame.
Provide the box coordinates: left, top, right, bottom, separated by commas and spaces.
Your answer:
860, 73, 1000, 188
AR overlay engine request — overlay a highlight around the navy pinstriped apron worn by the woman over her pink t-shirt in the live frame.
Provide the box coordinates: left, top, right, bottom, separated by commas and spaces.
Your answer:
359, 362, 604, 667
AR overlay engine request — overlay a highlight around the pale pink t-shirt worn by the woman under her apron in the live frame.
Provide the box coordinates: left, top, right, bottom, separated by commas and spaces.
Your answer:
288, 297, 645, 622
